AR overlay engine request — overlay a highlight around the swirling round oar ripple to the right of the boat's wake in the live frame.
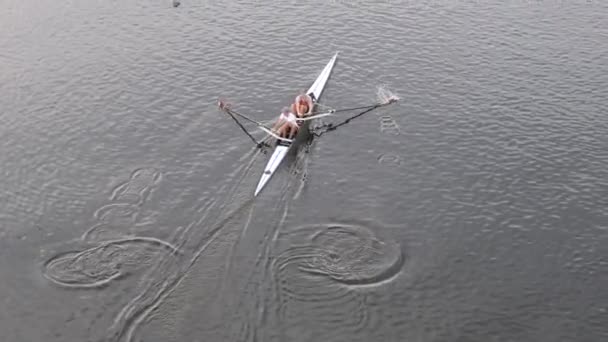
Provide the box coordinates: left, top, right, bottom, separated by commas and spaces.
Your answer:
272, 225, 403, 338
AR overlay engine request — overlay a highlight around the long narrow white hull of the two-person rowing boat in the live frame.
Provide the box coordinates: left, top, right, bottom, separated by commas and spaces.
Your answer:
254, 53, 338, 196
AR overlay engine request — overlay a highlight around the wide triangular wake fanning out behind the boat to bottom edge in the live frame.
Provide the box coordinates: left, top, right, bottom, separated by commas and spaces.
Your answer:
126, 149, 304, 341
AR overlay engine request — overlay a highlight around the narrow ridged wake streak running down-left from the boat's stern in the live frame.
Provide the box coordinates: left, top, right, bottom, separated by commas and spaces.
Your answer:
105, 150, 259, 341
